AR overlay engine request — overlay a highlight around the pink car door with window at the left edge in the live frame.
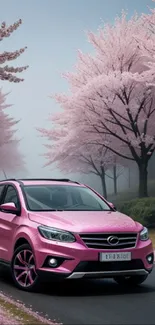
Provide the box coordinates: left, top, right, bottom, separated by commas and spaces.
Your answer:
0, 184, 20, 261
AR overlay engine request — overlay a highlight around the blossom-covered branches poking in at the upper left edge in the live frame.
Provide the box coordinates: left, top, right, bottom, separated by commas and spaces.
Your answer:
0, 19, 28, 83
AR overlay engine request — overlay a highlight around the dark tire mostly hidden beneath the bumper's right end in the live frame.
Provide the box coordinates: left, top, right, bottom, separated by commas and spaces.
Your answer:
114, 274, 148, 286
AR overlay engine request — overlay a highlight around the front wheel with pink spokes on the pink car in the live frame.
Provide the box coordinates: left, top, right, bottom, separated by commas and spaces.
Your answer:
11, 244, 40, 292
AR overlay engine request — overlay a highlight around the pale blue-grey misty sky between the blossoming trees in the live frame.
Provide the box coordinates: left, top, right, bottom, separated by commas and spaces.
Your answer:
0, 0, 153, 182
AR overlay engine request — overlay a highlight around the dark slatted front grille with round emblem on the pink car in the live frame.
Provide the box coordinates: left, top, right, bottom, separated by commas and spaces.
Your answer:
80, 233, 137, 250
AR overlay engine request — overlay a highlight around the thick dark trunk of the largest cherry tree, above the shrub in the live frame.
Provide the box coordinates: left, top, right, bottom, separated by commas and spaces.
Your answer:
138, 162, 148, 198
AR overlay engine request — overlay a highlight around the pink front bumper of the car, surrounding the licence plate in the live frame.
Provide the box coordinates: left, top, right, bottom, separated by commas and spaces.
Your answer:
35, 234, 153, 280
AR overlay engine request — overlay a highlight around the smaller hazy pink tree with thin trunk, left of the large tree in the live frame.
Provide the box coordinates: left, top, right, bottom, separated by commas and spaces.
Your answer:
38, 121, 115, 199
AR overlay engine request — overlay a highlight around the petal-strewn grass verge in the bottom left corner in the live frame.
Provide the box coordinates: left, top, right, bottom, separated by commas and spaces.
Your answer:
0, 293, 56, 325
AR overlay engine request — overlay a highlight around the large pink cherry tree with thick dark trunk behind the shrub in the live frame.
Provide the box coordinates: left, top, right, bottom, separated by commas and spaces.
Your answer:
66, 73, 155, 196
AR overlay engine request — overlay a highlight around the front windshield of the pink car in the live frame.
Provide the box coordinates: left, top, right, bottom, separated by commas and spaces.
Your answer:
23, 185, 111, 211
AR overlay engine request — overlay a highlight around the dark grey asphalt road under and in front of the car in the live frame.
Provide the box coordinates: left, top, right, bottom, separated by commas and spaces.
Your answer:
0, 269, 155, 325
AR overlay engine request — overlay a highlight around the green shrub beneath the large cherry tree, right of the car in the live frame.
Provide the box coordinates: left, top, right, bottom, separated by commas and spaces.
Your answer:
116, 197, 155, 228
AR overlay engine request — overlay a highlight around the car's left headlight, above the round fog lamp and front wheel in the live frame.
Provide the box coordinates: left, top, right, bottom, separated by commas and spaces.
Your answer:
38, 226, 76, 243
